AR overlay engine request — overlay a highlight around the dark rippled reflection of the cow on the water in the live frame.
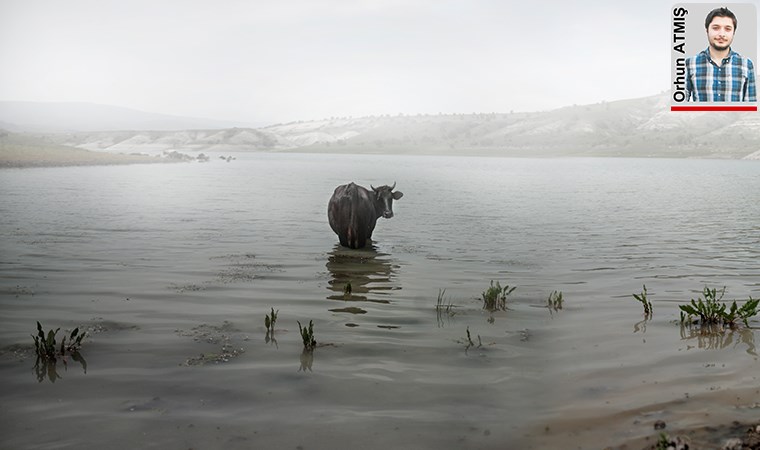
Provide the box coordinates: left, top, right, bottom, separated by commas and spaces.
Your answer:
327, 245, 399, 303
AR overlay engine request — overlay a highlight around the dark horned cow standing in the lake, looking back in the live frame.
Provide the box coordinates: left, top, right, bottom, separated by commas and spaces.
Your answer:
327, 183, 404, 248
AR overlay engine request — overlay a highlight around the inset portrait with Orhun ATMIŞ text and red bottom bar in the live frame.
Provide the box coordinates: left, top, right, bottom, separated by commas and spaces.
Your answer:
670, 3, 757, 111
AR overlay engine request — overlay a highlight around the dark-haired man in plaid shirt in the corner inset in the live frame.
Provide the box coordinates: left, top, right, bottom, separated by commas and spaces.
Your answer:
686, 8, 757, 102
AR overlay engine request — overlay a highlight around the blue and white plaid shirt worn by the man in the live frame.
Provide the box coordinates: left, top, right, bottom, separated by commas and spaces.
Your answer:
686, 48, 757, 102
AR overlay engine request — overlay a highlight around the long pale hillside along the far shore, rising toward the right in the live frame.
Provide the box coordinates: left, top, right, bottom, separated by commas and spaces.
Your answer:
13, 93, 760, 159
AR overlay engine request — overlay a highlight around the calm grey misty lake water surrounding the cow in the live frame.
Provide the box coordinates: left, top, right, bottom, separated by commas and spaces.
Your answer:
0, 154, 760, 449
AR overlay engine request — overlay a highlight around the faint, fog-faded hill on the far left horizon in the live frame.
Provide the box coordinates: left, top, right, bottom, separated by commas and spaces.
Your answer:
0, 102, 252, 133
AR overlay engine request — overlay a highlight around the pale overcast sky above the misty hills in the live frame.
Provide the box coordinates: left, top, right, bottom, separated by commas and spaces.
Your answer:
0, 0, 758, 124
